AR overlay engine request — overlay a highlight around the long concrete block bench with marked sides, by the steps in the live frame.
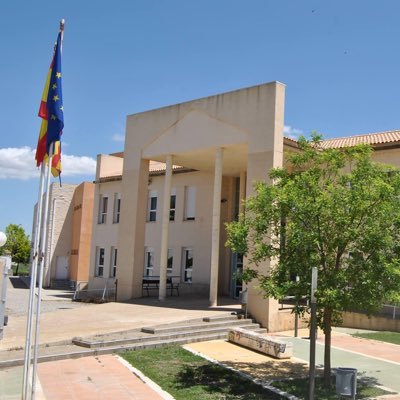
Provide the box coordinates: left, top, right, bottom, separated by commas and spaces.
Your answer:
228, 328, 293, 359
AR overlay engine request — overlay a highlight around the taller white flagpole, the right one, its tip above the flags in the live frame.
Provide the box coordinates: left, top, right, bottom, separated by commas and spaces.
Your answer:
31, 19, 65, 400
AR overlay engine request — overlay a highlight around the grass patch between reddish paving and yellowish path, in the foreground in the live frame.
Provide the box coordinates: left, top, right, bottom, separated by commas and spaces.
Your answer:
122, 346, 283, 400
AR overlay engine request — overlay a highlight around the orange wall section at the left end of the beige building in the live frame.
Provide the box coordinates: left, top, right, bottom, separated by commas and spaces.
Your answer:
69, 182, 94, 282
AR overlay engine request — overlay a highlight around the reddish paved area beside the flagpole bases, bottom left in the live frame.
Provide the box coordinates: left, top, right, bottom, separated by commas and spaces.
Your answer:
38, 355, 162, 400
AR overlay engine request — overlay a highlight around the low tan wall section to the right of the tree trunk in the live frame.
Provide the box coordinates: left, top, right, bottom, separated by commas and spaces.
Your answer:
342, 312, 400, 332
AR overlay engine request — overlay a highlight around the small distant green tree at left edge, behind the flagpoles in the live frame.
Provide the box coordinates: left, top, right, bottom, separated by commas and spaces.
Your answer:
0, 224, 31, 275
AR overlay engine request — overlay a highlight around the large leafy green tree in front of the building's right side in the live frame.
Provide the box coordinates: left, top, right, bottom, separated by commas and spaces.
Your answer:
227, 134, 400, 386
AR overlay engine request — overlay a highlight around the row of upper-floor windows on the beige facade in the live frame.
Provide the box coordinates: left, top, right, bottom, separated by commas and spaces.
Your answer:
98, 186, 196, 224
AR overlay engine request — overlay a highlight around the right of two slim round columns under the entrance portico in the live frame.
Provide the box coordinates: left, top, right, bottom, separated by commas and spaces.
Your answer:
210, 147, 222, 306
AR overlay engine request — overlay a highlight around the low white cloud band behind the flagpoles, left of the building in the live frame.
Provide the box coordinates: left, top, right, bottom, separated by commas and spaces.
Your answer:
0, 146, 96, 180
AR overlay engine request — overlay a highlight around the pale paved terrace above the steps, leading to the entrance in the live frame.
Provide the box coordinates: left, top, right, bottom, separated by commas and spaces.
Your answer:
0, 296, 240, 350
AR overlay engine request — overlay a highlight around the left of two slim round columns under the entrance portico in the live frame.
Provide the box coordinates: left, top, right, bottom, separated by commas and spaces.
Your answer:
158, 155, 172, 301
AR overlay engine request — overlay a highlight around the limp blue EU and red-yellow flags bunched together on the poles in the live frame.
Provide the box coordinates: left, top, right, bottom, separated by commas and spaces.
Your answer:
35, 32, 64, 176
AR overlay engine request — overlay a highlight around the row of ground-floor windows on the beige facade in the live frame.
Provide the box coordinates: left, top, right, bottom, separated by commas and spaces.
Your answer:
95, 246, 193, 283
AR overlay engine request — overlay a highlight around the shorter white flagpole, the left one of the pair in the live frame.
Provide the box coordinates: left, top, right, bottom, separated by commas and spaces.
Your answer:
22, 162, 46, 400
